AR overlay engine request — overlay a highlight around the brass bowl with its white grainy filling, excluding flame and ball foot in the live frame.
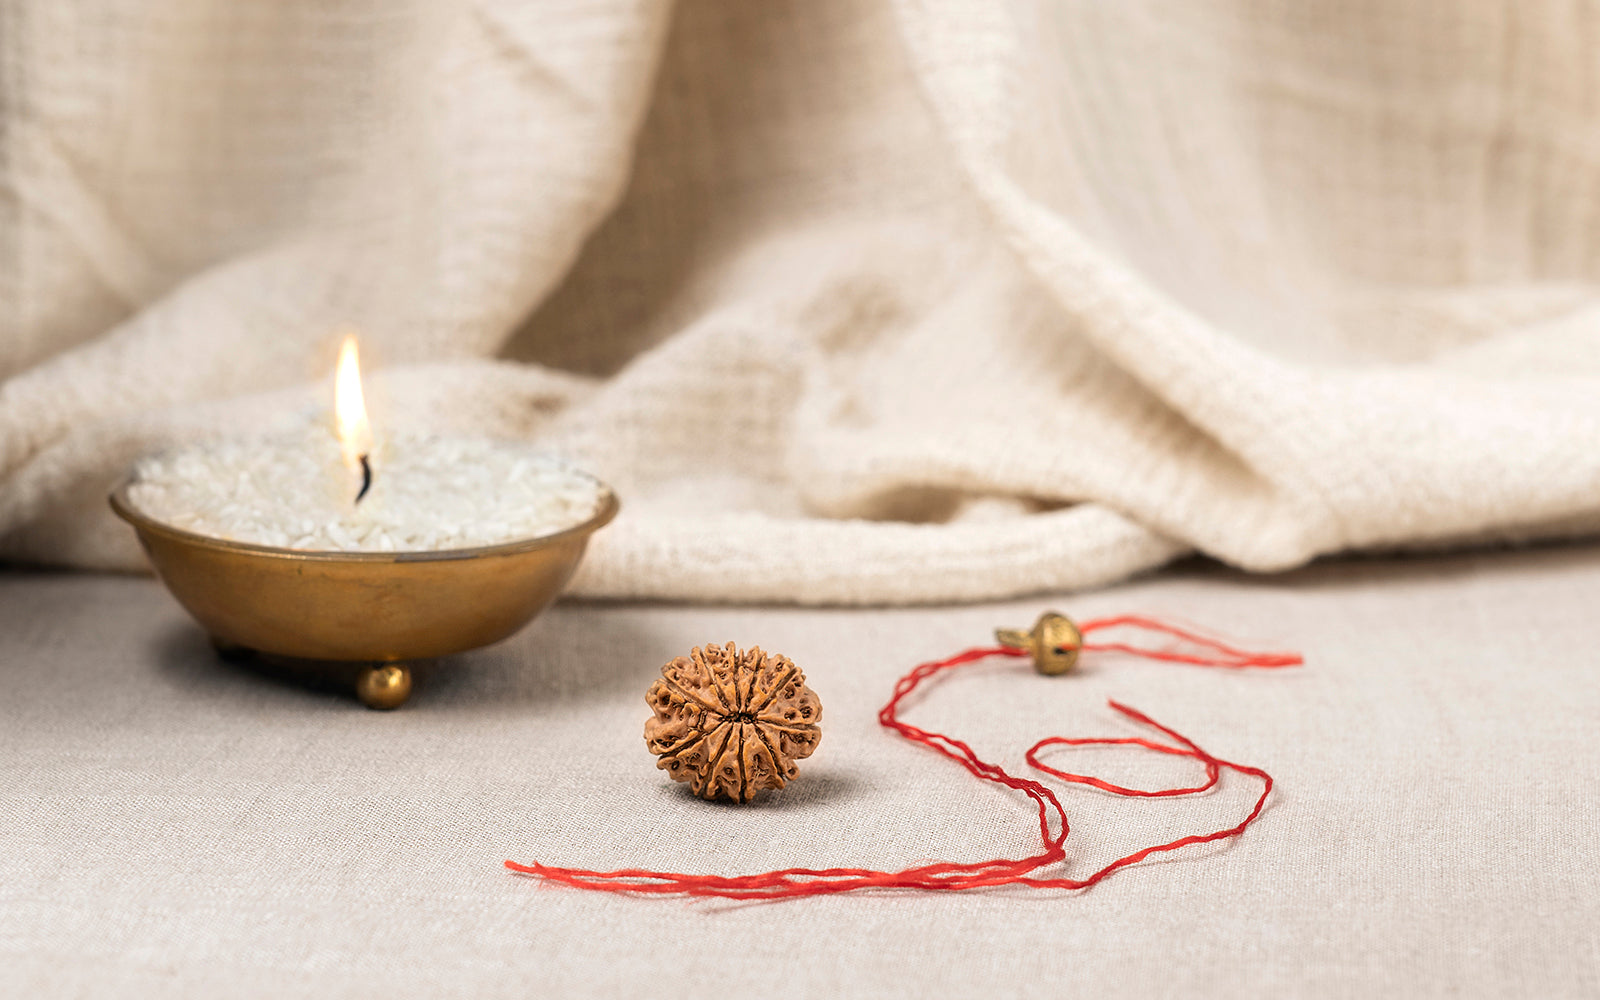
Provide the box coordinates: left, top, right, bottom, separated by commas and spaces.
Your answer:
110, 435, 618, 704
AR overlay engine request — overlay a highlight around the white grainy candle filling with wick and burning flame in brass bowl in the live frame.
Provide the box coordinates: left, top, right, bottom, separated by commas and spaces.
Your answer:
128, 334, 606, 552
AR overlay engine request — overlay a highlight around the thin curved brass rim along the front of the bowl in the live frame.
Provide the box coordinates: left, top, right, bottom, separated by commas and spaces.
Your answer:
106, 462, 622, 563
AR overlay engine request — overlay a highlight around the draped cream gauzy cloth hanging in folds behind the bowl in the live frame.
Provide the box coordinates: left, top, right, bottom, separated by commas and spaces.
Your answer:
0, 0, 1600, 602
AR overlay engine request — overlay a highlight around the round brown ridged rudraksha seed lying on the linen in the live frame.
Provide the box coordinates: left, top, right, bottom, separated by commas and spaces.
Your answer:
645, 643, 822, 802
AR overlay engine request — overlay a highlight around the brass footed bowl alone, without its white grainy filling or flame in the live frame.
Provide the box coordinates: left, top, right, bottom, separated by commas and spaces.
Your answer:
110, 477, 618, 709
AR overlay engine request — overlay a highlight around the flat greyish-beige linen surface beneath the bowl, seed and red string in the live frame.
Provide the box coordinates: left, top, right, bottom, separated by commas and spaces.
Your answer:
0, 547, 1600, 998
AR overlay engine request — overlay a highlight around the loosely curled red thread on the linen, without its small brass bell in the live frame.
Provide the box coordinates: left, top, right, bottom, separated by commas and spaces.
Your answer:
506, 614, 1304, 899
